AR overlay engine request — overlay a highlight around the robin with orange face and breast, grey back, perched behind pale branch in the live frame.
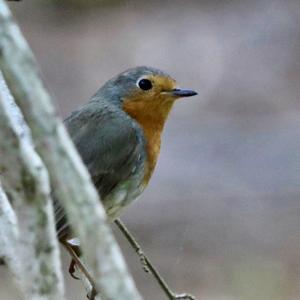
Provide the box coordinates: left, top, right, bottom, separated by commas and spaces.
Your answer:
54, 66, 197, 240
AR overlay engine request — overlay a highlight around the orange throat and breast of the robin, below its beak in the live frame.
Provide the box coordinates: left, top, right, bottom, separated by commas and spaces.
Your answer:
123, 101, 173, 184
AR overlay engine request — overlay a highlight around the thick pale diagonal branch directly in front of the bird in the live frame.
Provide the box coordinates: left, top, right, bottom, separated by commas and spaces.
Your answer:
0, 0, 141, 300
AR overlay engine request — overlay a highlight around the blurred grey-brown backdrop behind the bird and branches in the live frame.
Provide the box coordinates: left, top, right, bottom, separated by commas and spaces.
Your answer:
0, 0, 300, 300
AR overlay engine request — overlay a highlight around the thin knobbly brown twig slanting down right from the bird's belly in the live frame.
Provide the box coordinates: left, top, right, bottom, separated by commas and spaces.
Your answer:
115, 219, 195, 300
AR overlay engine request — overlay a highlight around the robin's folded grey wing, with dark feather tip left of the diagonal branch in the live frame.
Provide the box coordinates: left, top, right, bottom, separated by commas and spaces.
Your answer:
54, 102, 144, 237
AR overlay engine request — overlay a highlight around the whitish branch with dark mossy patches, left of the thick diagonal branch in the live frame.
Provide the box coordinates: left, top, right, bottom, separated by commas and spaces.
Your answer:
0, 73, 64, 300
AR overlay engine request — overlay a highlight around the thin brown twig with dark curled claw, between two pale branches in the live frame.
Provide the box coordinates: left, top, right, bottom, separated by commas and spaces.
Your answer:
61, 240, 97, 300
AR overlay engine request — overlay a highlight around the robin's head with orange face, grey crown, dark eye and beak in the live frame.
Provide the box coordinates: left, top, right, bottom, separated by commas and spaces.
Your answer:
99, 66, 197, 118
